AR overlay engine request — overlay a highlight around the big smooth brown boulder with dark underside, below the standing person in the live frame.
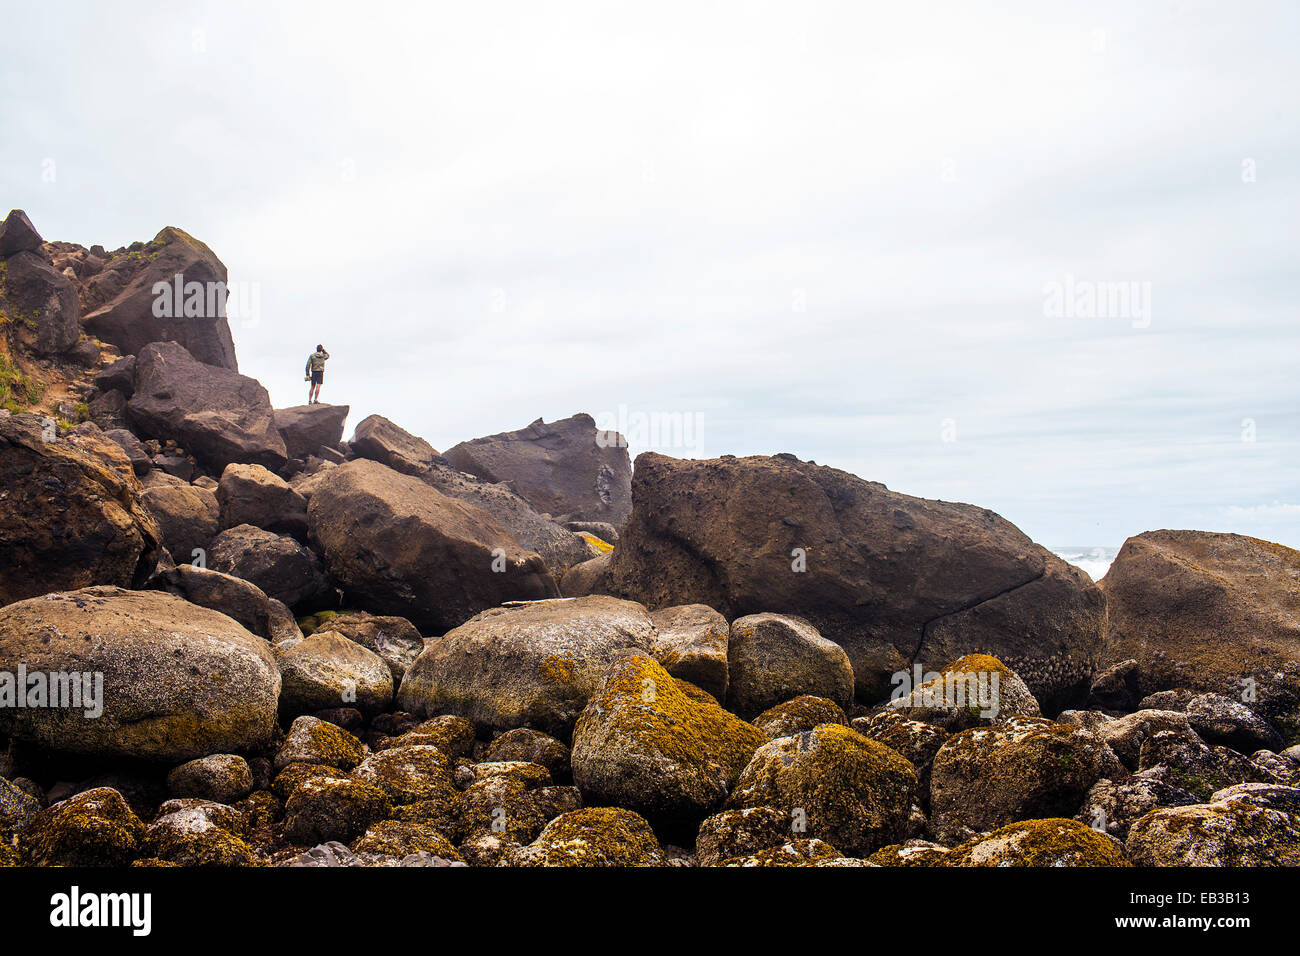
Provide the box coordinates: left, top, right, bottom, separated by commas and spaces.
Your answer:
307, 459, 558, 632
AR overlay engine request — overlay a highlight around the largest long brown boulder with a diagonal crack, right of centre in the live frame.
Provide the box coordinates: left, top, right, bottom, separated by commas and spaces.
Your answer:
603, 453, 1105, 712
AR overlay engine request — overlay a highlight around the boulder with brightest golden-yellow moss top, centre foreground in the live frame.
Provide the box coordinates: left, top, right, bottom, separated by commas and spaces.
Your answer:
572, 657, 767, 831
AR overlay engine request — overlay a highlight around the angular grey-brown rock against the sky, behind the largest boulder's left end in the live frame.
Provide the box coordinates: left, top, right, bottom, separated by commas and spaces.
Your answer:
445, 415, 632, 528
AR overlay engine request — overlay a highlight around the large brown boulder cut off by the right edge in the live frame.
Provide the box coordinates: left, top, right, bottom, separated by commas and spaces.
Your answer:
1101, 531, 1300, 739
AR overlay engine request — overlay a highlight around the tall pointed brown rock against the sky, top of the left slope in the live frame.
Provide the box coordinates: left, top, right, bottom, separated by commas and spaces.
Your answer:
82, 226, 239, 371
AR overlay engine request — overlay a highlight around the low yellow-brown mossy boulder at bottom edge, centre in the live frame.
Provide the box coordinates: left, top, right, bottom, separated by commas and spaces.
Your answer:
501, 806, 664, 866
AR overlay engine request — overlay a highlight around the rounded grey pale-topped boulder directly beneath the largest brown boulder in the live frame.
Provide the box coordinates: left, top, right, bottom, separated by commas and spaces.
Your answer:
727, 614, 853, 718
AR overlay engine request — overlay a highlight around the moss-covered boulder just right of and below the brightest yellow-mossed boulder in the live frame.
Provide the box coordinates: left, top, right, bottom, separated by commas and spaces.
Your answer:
727, 723, 917, 856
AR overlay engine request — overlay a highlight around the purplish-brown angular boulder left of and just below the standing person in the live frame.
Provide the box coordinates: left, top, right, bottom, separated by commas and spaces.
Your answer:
127, 342, 287, 473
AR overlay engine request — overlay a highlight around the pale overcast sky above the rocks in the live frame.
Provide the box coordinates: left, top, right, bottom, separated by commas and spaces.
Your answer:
0, 0, 1300, 546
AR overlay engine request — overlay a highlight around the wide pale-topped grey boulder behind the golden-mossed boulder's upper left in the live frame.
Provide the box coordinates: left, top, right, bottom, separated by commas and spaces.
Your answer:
395, 595, 654, 737
